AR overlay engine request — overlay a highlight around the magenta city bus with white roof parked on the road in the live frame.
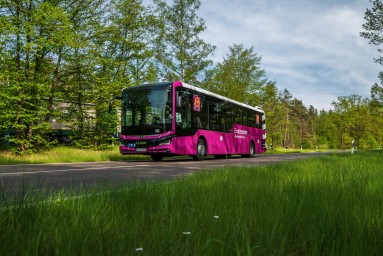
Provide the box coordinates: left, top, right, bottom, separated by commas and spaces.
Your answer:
119, 81, 266, 161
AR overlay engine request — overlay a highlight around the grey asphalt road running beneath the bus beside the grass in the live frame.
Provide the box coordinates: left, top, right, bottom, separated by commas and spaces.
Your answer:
0, 153, 321, 196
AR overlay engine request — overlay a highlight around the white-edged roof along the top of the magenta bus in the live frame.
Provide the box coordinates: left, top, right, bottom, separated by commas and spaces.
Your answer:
123, 81, 265, 113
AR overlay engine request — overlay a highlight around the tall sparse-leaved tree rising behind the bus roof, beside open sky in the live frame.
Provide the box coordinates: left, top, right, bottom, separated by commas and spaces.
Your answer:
154, 0, 215, 84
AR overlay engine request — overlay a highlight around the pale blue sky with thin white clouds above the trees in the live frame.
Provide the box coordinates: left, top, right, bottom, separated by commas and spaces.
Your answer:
197, 0, 380, 110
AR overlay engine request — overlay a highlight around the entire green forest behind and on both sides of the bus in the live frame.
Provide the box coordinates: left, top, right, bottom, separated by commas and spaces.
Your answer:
0, 0, 383, 153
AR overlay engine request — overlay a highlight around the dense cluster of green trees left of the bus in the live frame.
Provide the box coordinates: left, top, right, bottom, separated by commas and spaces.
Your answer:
0, 0, 155, 152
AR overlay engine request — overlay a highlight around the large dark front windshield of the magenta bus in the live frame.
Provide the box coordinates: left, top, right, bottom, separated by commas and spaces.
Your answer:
121, 84, 172, 135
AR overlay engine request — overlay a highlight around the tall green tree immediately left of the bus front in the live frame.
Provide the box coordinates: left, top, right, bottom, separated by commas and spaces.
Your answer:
88, 0, 156, 147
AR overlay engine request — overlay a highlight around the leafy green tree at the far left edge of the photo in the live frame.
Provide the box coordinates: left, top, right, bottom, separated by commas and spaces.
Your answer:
0, 0, 71, 152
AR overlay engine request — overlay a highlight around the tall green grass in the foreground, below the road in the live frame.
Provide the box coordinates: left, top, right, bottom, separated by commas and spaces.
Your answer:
0, 152, 383, 255
